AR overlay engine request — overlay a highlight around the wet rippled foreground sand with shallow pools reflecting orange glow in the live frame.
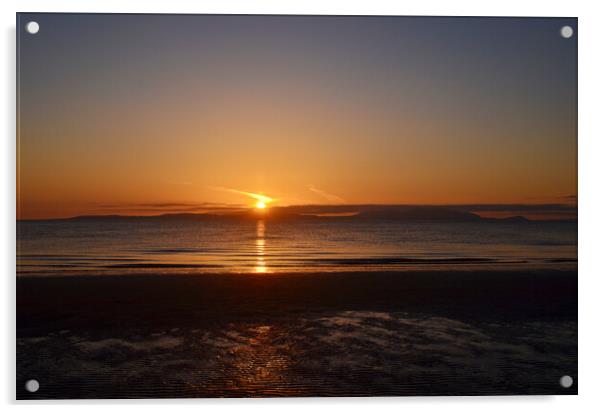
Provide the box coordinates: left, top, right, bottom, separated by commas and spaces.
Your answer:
17, 311, 577, 398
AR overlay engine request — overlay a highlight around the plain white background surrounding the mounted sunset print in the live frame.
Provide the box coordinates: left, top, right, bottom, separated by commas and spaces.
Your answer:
0, 0, 602, 413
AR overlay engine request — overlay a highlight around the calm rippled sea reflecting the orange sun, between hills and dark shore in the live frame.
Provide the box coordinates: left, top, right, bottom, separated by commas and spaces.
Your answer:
17, 219, 577, 275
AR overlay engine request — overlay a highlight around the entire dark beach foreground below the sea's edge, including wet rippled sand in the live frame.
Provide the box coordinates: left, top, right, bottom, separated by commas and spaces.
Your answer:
17, 270, 577, 399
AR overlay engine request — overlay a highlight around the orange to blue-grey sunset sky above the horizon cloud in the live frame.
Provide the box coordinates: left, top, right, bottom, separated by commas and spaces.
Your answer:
17, 14, 577, 219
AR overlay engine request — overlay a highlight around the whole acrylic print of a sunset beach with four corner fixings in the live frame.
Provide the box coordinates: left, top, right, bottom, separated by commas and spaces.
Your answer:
16, 14, 578, 399
